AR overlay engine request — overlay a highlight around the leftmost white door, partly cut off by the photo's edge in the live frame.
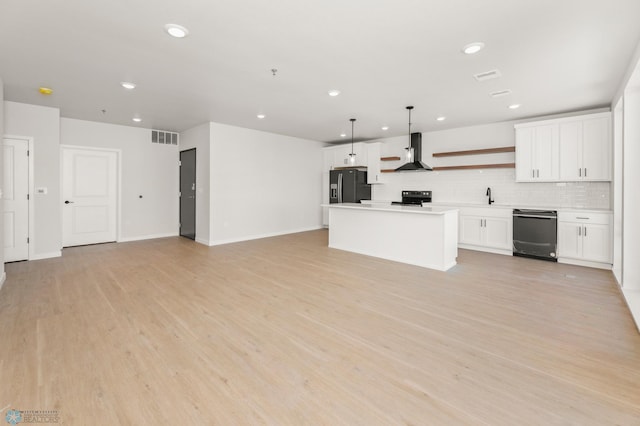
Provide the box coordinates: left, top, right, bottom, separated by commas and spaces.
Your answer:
2, 139, 29, 262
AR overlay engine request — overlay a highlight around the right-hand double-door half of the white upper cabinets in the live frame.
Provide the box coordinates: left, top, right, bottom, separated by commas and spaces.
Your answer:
560, 113, 611, 181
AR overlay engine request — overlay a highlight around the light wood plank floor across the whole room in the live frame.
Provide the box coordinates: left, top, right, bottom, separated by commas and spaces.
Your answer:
0, 231, 640, 425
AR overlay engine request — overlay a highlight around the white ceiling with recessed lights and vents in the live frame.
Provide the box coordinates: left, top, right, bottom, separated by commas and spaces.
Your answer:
0, 0, 640, 142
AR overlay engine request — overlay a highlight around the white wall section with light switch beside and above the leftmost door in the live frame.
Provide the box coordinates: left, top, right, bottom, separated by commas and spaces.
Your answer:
4, 101, 62, 259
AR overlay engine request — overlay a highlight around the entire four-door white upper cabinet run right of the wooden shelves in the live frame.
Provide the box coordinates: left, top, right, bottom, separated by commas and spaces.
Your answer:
515, 112, 611, 182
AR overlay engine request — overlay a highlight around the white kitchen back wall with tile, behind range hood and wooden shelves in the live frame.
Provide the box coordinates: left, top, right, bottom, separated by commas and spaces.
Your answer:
372, 110, 611, 209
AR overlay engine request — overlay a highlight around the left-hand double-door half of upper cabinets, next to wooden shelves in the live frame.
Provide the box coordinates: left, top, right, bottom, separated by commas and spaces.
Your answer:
516, 123, 560, 182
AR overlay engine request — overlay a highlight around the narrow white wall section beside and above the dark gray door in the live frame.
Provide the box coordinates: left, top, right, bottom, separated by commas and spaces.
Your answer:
179, 123, 211, 245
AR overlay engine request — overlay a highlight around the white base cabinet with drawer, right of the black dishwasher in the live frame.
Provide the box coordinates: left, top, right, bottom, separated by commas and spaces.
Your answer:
558, 211, 612, 269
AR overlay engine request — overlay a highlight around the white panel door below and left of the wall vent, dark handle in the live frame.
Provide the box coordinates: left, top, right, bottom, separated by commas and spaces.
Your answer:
62, 147, 118, 247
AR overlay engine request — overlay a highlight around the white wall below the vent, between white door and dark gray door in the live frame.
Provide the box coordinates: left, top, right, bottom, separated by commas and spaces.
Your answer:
60, 118, 179, 241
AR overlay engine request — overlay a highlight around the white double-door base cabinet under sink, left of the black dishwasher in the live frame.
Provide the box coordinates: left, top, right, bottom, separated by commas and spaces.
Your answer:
458, 207, 513, 255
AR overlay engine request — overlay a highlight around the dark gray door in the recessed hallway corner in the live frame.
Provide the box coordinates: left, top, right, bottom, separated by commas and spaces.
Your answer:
180, 148, 196, 240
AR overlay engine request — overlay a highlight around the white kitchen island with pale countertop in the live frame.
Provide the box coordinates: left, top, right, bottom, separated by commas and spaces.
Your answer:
326, 203, 458, 271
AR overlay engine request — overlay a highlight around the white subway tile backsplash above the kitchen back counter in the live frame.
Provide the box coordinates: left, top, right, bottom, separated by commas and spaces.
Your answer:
372, 169, 611, 209
